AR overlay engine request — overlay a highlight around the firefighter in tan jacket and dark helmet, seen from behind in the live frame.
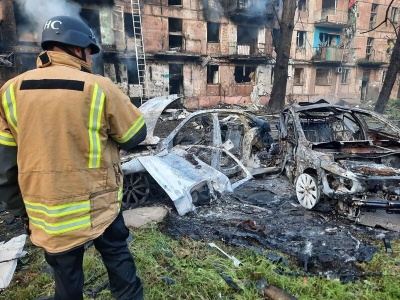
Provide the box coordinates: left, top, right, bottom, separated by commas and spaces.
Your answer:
0, 16, 146, 300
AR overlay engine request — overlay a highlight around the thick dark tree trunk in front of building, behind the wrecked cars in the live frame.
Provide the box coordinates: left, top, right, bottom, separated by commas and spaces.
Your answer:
267, 0, 297, 113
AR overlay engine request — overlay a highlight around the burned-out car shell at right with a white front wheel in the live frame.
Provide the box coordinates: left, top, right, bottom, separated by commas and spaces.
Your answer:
279, 100, 400, 227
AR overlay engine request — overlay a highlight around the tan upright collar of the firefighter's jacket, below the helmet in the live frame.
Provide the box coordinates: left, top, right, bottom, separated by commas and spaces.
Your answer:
36, 51, 92, 73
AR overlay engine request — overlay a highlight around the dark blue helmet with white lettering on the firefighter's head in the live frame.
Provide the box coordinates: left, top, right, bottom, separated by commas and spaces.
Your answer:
41, 16, 100, 54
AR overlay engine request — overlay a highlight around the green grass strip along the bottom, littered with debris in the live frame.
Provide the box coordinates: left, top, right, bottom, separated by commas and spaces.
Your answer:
0, 224, 400, 300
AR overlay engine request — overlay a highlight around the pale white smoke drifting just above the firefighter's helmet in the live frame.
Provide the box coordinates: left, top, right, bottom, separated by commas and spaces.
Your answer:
17, 0, 81, 43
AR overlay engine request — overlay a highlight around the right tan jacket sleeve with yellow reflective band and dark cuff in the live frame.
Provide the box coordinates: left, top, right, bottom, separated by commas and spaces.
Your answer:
105, 81, 147, 150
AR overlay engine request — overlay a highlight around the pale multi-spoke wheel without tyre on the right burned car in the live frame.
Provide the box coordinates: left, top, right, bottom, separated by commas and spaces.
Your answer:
296, 173, 319, 209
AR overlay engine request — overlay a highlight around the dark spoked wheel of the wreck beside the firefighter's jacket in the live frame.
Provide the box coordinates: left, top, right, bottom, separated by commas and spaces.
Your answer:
122, 173, 150, 208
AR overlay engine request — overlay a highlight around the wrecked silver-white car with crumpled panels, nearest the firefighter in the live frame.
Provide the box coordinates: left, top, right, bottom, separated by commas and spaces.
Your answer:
122, 95, 279, 215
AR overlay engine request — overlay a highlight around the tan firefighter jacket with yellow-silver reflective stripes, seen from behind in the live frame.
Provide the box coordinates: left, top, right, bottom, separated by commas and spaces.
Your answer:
0, 51, 146, 253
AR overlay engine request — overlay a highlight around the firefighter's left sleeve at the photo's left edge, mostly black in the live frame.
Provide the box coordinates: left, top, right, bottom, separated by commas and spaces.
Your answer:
0, 99, 26, 216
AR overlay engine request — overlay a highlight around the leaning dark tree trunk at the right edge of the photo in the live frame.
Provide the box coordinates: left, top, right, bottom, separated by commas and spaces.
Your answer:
374, 31, 400, 114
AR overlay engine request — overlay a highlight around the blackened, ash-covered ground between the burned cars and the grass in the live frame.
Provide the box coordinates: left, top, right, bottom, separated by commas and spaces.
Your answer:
158, 175, 400, 282
